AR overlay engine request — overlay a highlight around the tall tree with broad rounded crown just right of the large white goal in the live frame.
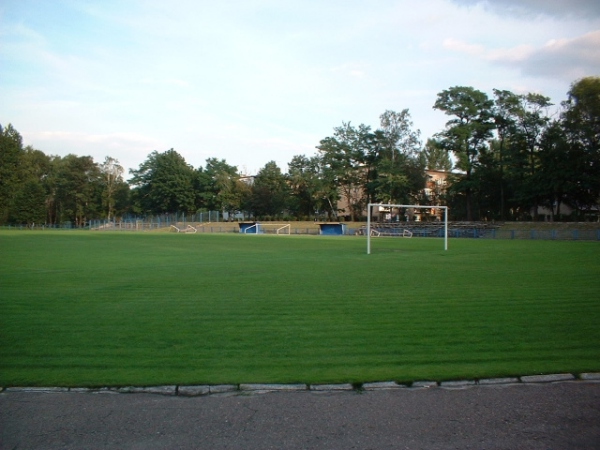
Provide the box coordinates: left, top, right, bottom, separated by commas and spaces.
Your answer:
433, 86, 494, 220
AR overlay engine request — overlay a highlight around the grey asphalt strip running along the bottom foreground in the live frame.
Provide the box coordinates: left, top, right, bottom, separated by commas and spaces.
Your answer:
0, 381, 600, 450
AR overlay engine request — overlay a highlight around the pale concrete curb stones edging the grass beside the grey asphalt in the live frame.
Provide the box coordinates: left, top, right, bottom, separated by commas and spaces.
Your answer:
0, 372, 600, 397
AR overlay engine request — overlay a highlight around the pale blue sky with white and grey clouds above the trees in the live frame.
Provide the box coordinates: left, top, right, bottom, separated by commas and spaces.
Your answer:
0, 0, 600, 178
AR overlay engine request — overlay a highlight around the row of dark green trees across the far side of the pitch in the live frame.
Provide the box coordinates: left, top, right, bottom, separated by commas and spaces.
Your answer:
0, 77, 600, 226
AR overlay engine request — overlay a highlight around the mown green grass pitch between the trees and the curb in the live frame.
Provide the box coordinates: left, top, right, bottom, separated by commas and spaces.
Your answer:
0, 231, 600, 386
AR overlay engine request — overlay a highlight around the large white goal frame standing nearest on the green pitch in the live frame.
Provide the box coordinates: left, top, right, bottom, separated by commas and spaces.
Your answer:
366, 203, 448, 255
